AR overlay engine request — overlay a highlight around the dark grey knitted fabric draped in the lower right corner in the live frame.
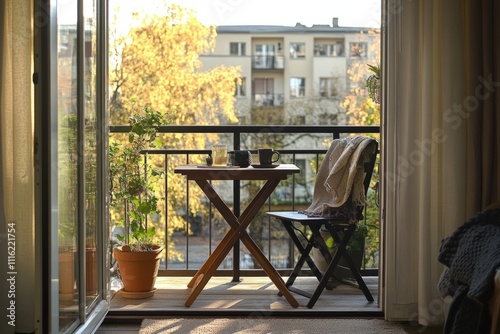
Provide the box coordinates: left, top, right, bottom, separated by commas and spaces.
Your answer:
438, 208, 500, 334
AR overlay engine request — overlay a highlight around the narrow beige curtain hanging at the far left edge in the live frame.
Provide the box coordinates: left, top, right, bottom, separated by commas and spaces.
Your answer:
0, 0, 35, 333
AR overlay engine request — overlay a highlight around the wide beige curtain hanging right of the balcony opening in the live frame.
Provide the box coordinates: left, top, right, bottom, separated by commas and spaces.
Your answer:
382, 0, 500, 325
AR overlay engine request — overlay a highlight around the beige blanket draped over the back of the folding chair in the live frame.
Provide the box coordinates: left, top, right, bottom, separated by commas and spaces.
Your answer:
301, 136, 375, 220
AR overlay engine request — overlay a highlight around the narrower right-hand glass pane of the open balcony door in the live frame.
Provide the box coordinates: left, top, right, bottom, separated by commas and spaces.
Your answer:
83, 0, 98, 313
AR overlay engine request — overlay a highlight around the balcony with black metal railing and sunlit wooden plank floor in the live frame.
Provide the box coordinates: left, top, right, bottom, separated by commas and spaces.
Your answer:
105, 125, 380, 317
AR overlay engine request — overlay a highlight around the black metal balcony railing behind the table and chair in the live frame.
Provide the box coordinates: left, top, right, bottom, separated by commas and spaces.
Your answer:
110, 126, 380, 280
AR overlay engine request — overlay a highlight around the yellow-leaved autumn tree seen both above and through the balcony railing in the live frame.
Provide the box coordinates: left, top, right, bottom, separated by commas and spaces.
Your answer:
109, 4, 241, 259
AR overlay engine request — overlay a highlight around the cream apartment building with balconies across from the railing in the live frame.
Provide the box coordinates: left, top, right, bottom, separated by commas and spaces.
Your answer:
201, 18, 380, 131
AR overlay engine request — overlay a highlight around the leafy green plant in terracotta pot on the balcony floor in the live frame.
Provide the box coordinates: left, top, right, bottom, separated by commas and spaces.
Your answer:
109, 101, 169, 299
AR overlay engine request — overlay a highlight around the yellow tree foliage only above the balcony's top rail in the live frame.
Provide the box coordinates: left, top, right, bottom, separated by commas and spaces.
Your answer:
110, 5, 241, 125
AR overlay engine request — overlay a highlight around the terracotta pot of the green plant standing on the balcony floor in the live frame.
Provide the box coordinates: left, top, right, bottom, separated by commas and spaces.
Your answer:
113, 246, 163, 299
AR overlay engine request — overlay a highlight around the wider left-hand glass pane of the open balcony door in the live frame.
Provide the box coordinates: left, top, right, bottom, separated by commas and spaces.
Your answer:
57, 0, 79, 332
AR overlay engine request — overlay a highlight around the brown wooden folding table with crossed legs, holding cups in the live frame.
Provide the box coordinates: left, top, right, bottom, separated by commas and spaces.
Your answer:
174, 164, 300, 308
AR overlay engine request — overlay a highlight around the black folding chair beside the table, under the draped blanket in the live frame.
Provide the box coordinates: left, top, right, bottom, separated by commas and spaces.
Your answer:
267, 136, 378, 308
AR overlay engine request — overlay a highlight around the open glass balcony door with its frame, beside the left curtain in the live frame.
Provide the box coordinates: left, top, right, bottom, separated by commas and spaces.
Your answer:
35, 0, 109, 333
